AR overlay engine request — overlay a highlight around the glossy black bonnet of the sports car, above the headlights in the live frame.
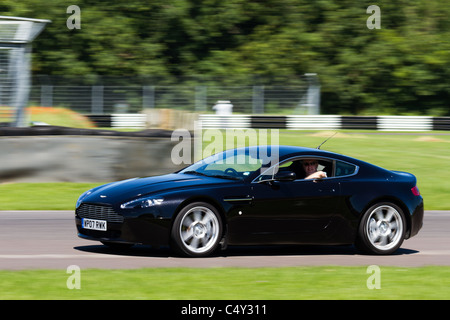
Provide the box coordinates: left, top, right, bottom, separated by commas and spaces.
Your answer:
83, 173, 236, 204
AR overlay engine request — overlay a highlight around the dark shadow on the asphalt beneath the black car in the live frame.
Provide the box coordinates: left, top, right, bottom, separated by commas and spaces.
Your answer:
74, 244, 419, 258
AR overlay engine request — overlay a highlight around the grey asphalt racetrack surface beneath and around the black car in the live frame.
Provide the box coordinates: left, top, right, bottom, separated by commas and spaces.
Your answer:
0, 211, 450, 270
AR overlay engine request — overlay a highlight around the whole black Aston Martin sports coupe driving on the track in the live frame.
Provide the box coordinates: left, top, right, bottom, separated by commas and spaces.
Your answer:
75, 146, 424, 257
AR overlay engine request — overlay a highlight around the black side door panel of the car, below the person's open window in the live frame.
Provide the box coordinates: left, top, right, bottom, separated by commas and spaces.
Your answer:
229, 158, 339, 244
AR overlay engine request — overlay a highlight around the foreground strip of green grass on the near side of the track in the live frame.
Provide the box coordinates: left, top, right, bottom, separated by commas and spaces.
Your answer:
0, 266, 450, 300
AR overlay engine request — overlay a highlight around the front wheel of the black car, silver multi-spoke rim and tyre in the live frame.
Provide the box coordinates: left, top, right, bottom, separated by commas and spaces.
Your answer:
171, 202, 222, 257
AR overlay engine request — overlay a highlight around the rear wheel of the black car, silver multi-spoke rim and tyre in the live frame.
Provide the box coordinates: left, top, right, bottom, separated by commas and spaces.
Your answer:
356, 202, 406, 255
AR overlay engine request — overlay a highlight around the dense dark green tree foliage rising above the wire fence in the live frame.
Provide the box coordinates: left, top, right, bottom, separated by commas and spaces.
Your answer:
0, 0, 450, 115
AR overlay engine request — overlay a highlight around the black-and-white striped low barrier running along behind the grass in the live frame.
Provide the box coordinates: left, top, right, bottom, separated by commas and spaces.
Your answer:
88, 114, 450, 131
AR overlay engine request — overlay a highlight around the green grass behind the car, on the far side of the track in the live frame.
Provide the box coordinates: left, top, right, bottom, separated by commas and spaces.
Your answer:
0, 130, 450, 210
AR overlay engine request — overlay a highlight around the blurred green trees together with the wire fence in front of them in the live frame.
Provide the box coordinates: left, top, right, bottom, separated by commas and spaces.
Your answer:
0, 0, 450, 127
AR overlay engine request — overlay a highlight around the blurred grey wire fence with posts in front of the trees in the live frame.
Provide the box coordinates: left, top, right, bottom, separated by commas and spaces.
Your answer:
30, 74, 320, 114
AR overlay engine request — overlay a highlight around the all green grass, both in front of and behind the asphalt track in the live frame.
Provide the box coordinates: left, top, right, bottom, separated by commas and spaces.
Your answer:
0, 131, 450, 300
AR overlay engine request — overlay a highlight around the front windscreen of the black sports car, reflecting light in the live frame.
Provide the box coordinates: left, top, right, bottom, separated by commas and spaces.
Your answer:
179, 148, 273, 180
